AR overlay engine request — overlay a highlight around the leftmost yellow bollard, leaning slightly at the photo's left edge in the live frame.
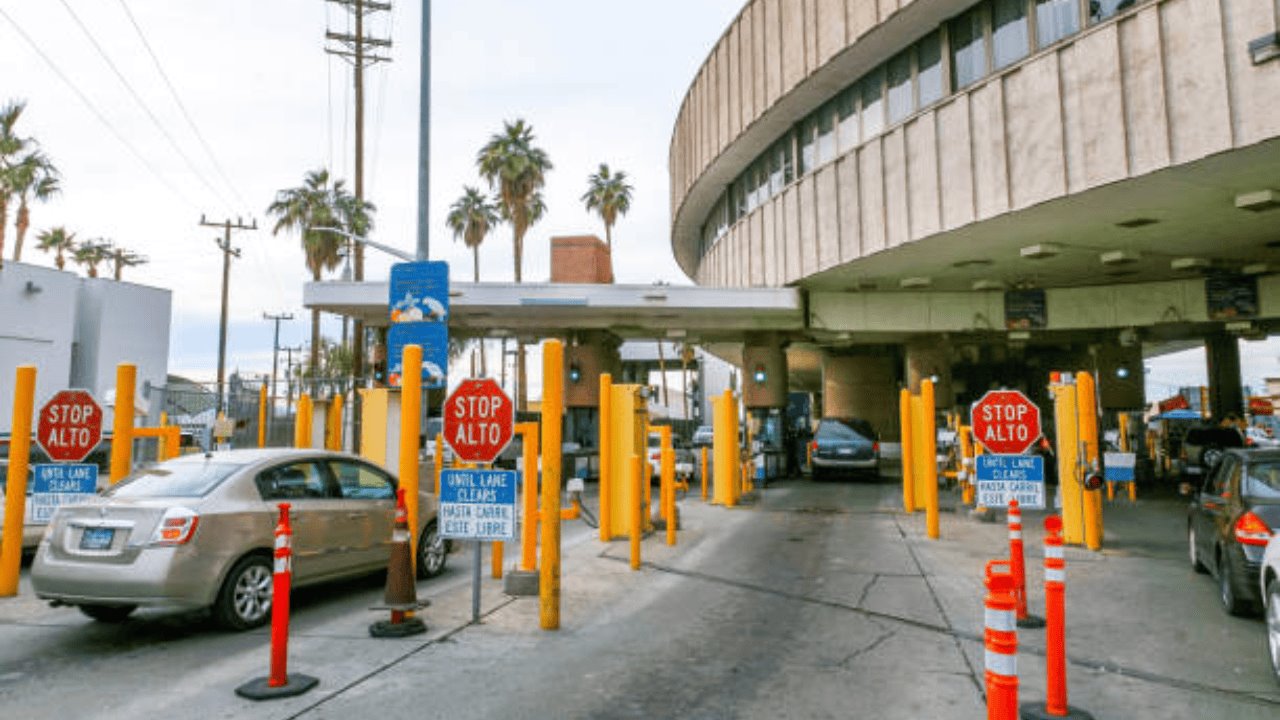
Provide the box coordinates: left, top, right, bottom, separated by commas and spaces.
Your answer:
0, 365, 36, 597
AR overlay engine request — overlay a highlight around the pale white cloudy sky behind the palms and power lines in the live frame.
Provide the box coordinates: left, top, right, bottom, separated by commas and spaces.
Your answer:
0, 0, 1280, 397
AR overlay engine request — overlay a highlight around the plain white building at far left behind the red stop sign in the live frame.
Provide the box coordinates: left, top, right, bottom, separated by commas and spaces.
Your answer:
0, 263, 173, 436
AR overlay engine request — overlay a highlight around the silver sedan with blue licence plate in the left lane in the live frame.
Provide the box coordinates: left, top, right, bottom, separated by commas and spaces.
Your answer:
31, 448, 448, 629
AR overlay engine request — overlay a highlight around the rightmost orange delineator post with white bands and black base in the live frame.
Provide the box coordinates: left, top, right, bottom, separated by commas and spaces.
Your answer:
1020, 515, 1093, 720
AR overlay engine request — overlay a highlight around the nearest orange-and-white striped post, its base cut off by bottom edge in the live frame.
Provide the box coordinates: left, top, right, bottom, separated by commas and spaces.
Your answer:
983, 560, 1018, 720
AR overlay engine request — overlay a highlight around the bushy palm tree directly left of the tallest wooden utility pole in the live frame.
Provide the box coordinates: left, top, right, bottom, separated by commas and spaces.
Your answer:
266, 168, 343, 368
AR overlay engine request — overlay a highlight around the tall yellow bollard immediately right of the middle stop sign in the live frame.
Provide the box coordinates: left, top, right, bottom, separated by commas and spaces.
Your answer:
538, 340, 564, 630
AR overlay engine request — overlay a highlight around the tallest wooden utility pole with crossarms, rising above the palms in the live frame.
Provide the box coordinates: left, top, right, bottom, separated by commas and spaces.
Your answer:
324, 0, 392, 450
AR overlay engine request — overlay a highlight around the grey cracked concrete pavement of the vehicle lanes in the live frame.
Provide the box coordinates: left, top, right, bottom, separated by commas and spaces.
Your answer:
0, 478, 1280, 719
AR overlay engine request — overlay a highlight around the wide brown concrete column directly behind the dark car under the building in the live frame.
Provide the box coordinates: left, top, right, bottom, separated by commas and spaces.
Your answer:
822, 352, 900, 442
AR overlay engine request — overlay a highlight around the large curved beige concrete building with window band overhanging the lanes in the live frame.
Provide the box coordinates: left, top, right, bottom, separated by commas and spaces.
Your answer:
669, 0, 1280, 438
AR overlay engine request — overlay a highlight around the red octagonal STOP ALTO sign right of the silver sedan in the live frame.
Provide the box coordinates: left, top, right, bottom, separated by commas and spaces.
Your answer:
444, 378, 516, 462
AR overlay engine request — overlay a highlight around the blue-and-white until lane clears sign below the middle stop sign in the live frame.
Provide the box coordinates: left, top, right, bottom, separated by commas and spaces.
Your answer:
439, 470, 516, 541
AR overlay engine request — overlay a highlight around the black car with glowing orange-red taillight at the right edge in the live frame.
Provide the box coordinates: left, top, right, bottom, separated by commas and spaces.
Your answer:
1187, 450, 1280, 615
